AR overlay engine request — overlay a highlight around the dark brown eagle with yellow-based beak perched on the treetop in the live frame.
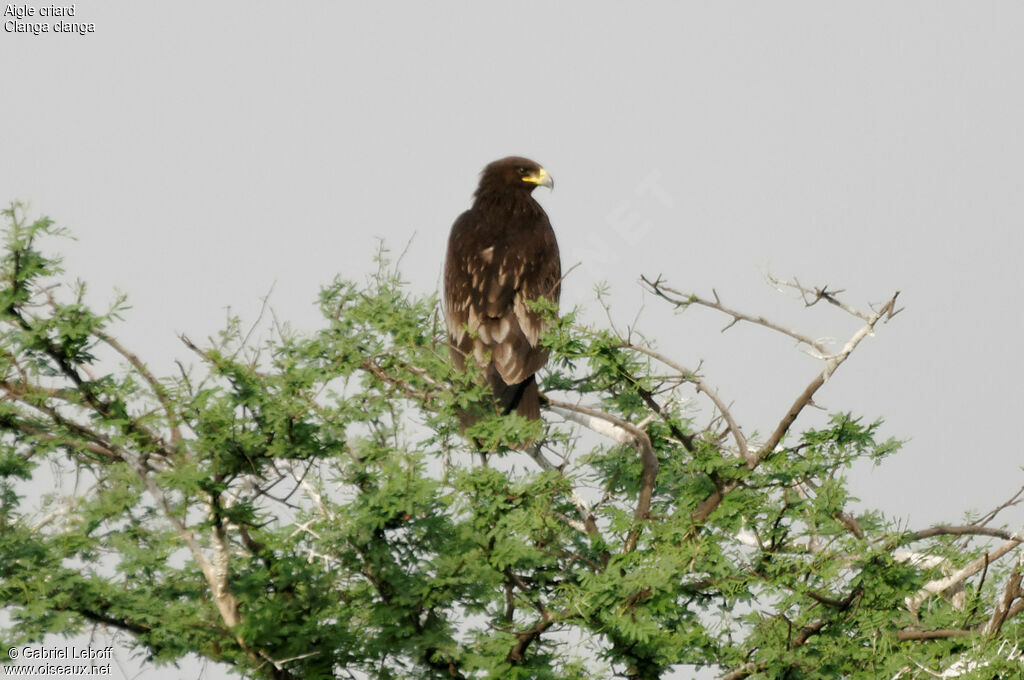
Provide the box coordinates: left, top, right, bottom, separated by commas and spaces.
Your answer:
444, 157, 562, 425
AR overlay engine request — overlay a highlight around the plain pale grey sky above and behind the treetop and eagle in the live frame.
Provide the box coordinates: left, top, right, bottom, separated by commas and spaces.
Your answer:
0, 0, 1024, 677
